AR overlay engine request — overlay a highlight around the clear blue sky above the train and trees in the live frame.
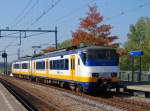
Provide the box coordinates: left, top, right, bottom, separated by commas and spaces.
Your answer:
0, 0, 150, 61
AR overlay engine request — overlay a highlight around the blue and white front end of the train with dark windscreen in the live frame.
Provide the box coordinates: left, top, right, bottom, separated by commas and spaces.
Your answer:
80, 48, 119, 90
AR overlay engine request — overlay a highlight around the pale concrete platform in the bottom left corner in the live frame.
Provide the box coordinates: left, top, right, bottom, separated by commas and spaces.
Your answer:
0, 83, 27, 111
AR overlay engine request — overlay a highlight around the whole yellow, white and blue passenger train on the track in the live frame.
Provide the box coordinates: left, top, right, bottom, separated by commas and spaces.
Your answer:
12, 46, 119, 91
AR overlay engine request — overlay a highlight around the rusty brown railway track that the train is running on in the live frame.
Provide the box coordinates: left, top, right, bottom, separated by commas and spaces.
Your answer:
29, 78, 150, 111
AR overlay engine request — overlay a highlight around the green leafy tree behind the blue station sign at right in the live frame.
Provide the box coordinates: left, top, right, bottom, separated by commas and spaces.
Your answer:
120, 17, 150, 70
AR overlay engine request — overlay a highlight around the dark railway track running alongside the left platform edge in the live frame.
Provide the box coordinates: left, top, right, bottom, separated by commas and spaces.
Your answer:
0, 77, 62, 111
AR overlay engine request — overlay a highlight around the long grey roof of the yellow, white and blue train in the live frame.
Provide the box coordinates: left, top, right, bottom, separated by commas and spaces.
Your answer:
14, 46, 114, 62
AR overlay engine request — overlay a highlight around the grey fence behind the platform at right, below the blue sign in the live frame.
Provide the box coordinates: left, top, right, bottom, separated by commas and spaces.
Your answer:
119, 71, 150, 82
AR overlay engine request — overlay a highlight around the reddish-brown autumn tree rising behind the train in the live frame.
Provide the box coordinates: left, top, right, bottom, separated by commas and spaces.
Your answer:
72, 5, 118, 48
